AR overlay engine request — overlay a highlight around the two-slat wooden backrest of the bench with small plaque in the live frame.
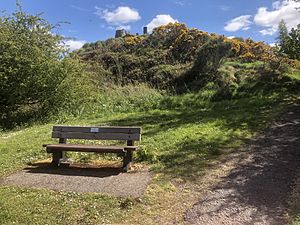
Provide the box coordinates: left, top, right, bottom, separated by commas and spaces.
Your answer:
52, 126, 142, 141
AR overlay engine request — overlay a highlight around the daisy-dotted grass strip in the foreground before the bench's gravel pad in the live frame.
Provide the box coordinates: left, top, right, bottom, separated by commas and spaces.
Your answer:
0, 187, 131, 224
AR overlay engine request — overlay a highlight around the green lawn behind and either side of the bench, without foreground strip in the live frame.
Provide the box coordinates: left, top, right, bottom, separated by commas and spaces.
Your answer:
0, 95, 281, 176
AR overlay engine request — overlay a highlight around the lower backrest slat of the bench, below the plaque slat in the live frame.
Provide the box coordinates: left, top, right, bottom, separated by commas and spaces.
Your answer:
52, 132, 141, 141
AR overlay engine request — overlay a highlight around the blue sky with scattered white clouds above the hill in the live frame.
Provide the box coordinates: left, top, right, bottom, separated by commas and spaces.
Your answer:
0, 0, 300, 49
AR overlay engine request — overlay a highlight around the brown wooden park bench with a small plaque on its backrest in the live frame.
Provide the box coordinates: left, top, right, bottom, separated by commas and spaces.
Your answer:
43, 126, 141, 171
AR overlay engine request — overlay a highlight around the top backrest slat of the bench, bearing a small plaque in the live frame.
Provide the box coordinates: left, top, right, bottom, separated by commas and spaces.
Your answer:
53, 126, 142, 134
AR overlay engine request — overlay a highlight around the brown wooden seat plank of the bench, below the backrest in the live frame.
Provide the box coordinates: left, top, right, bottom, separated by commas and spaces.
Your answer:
45, 144, 138, 153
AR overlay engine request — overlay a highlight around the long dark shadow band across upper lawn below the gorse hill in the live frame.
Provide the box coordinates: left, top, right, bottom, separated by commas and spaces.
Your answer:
107, 98, 278, 137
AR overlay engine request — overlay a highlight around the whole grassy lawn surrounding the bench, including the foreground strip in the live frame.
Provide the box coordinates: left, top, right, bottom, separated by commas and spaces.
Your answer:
0, 90, 298, 224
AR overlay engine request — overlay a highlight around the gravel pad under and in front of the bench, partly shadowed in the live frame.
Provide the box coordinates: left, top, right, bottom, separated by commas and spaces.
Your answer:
0, 163, 151, 197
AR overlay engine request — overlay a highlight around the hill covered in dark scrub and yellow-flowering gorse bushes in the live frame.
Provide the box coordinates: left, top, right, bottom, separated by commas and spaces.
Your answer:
75, 23, 299, 105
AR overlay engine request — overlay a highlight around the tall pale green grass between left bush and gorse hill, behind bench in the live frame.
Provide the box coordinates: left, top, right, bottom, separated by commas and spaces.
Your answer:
53, 84, 166, 123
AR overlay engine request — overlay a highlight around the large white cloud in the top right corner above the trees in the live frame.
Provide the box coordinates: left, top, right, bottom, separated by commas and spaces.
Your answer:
254, 0, 300, 35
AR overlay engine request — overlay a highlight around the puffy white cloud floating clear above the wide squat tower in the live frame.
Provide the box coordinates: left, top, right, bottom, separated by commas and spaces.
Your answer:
95, 6, 141, 25
